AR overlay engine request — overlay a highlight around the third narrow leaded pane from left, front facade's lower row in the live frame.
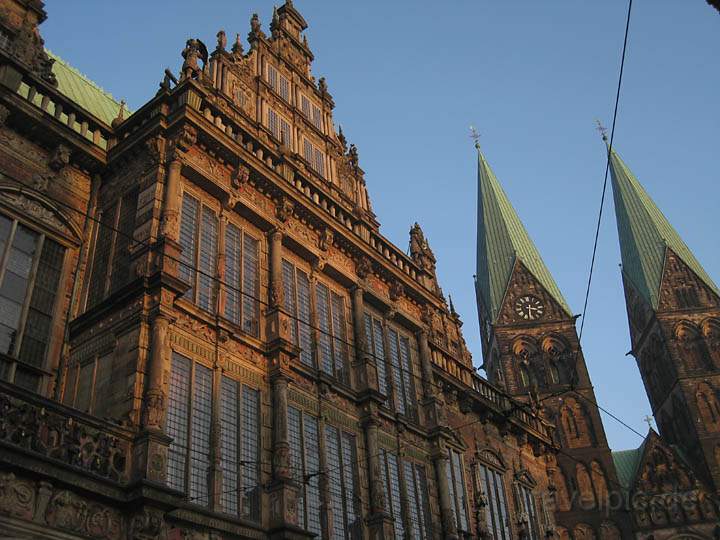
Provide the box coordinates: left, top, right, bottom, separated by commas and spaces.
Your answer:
220, 376, 239, 515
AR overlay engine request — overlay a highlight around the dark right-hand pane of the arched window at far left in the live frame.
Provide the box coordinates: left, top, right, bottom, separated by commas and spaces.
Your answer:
18, 238, 65, 367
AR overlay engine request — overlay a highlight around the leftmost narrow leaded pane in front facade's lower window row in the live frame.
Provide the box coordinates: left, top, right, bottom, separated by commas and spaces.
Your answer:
166, 354, 190, 491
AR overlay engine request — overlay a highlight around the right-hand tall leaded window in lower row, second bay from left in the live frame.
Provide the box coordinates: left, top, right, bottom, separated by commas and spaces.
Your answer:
325, 426, 360, 540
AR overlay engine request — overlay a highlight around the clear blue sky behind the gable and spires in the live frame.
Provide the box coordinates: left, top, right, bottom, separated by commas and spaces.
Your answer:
41, 0, 720, 449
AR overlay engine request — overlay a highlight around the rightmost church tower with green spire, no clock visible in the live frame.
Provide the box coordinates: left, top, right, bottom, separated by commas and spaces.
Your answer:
610, 146, 720, 490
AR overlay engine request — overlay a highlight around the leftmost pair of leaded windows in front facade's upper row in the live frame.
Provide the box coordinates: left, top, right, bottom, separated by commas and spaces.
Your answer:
179, 193, 260, 337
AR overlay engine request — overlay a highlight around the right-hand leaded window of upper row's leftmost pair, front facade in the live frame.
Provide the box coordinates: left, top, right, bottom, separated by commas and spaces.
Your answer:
225, 223, 260, 336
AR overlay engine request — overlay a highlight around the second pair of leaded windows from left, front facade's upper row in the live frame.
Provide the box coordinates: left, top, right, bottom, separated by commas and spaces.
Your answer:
283, 259, 350, 384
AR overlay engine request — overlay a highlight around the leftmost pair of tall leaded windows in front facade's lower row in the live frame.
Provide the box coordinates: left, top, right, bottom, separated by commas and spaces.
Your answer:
166, 353, 260, 521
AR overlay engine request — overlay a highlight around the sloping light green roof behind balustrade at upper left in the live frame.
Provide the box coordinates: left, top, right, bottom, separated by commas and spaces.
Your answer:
45, 49, 130, 125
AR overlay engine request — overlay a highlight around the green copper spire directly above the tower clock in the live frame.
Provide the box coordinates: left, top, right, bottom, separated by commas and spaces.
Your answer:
477, 151, 572, 322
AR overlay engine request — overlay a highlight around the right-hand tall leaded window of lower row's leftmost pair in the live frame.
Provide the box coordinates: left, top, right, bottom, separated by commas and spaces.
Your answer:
220, 376, 260, 521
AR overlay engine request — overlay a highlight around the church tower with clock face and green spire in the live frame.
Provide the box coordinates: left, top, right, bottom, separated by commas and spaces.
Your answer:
475, 143, 626, 538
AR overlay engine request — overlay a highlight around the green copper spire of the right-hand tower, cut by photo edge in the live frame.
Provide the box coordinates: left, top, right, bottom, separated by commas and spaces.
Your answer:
610, 149, 720, 308
